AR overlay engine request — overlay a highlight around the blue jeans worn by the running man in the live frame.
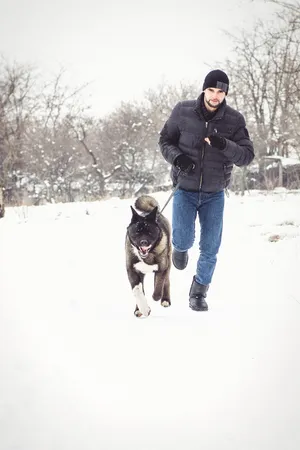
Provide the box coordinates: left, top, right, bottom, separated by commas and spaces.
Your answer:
172, 189, 224, 285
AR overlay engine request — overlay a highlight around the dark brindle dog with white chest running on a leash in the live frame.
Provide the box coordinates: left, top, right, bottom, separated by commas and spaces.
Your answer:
125, 195, 171, 317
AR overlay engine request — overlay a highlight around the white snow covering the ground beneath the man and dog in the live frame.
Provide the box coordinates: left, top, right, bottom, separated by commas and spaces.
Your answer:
0, 190, 300, 450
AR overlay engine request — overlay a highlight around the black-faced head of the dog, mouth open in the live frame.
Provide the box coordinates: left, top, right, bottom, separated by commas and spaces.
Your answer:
127, 206, 161, 258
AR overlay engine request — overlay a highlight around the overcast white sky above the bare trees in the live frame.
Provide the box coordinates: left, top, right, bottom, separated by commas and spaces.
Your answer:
0, 0, 273, 114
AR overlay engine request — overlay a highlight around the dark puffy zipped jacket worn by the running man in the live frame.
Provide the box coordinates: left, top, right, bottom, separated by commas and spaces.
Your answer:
159, 94, 254, 192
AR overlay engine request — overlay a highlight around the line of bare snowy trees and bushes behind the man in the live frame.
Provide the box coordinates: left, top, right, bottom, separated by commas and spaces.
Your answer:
0, 1, 300, 205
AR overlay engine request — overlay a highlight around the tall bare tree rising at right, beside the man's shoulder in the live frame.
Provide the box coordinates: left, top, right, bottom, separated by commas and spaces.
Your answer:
227, 2, 300, 162
